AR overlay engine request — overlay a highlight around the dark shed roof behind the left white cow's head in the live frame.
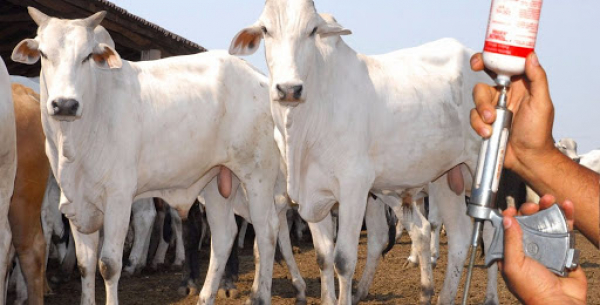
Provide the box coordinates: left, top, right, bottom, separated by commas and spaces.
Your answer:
0, 0, 206, 77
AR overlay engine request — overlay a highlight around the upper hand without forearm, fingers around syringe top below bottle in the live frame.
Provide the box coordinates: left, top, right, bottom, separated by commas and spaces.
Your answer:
471, 53, 558, 177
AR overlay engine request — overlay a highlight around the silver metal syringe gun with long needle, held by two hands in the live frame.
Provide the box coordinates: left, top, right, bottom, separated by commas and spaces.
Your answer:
462, 77, 579, 304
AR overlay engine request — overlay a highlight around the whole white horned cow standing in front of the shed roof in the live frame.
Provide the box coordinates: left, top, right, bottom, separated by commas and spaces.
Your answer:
12, 8, 280, 304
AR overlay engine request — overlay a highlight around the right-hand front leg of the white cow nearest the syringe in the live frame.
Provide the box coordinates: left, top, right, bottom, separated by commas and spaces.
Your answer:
334, 185, 369, 304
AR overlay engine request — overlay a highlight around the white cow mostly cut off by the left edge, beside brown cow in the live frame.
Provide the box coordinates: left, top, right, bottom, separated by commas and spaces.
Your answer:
0, 58, 17, 304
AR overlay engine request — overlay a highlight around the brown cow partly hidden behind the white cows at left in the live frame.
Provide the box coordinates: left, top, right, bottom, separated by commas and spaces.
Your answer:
8, 84, 49, 304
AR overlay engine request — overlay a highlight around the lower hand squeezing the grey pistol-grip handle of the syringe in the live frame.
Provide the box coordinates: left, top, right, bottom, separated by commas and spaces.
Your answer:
498, 195, 587, 304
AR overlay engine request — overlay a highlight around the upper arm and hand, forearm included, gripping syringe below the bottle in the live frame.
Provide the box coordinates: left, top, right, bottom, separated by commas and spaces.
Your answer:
471, 53, 600, 247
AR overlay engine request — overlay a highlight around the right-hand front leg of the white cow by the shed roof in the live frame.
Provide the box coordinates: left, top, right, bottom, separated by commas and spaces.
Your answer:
98, 197, 132, 305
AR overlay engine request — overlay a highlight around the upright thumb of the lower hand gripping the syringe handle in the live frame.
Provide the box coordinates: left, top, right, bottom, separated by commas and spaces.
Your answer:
502, 216, 525, 273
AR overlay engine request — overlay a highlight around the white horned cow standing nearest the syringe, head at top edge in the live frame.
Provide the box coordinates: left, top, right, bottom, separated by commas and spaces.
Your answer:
229, 0, 491, 304
